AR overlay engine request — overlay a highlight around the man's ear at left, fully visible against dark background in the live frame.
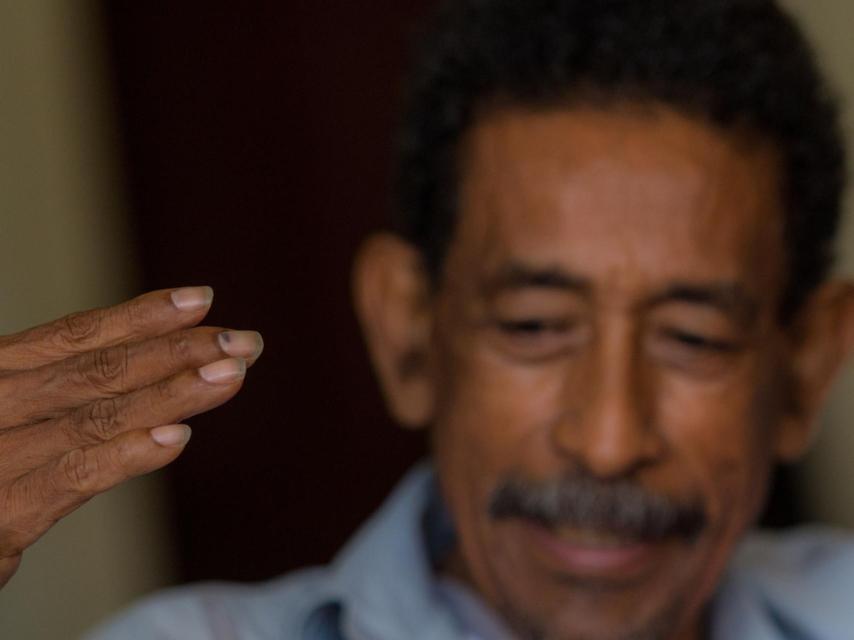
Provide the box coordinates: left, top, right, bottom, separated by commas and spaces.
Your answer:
353, 233, 434, 429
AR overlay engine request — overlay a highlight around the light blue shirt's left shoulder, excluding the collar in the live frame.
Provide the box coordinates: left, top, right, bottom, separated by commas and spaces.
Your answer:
87, 569, 340, 640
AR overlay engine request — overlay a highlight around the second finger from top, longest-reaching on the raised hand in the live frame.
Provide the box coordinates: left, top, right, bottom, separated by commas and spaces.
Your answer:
0, 327, 264, 427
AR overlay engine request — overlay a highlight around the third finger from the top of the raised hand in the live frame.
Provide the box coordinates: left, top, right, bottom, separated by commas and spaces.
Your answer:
10, 358, 246, 462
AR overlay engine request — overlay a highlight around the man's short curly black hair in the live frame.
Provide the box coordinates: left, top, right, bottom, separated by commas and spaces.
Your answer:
394, 0, 846, 318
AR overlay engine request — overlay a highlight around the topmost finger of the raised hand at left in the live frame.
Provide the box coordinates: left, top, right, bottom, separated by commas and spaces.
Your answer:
0, 287, 213, 371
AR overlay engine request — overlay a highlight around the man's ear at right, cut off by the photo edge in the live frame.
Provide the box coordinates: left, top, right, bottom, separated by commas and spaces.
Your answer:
776, 281, 854, 461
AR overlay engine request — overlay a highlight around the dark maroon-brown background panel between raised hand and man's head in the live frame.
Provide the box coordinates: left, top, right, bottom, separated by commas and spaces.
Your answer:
98, 0, 794, 580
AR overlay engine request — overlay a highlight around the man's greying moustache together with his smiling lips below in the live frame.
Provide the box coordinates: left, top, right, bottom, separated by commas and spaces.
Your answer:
488, 472, 707, 588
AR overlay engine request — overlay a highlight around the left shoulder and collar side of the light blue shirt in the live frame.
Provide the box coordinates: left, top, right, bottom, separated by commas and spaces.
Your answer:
88, 465, 442, 640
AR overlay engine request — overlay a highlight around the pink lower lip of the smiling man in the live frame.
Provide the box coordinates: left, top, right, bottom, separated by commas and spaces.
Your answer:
523, 524, 660, 579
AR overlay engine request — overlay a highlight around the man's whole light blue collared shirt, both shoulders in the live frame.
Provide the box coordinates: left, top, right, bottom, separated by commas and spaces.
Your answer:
89, 465, 854, 640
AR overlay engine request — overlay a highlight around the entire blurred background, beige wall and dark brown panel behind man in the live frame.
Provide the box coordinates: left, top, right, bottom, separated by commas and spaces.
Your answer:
0, 0, 854, 640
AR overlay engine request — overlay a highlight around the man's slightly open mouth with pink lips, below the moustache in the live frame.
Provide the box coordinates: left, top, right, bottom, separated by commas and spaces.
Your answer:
522, 522, 667, 583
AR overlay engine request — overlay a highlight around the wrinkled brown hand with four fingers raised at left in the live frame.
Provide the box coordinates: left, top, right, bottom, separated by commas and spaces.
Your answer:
0, 287, 263, 587
